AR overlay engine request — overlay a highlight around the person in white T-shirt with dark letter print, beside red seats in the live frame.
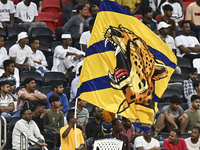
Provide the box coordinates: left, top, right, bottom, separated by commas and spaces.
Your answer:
14, 0, 46, 31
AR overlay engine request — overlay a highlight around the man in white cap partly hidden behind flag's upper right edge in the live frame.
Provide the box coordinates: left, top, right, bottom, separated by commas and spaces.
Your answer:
158, 21, 176, 53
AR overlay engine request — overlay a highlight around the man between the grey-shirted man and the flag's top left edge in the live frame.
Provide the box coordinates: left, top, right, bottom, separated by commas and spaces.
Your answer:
84, 5, 98, 29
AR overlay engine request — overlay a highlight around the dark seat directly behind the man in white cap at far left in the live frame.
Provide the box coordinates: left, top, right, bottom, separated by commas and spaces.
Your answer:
8, 26, 28, 42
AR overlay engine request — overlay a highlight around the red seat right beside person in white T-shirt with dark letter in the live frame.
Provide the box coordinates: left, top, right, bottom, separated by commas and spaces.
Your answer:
35, 12, 56, 33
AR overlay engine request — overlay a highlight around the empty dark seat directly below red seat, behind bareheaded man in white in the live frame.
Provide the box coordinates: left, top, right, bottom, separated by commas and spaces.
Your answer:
30, 27, 53, 47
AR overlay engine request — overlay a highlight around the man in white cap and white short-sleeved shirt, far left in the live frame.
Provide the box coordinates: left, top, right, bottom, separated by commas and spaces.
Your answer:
9, 32, 35, 72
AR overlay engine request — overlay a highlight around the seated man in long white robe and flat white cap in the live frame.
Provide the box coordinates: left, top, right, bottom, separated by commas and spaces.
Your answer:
51, 34, 85, 77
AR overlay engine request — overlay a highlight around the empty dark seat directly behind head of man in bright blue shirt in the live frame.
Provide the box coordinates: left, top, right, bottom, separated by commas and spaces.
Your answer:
44, 72, 67, 87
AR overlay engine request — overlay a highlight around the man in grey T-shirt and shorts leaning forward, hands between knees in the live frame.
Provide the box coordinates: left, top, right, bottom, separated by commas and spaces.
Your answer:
161, 95, 188, 133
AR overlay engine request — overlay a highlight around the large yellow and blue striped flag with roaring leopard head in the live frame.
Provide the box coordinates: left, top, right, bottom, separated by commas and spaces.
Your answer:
77, 0, 177, 131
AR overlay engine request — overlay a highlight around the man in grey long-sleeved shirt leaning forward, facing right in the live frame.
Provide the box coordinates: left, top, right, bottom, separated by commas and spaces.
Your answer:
62, 5, 87, 46
